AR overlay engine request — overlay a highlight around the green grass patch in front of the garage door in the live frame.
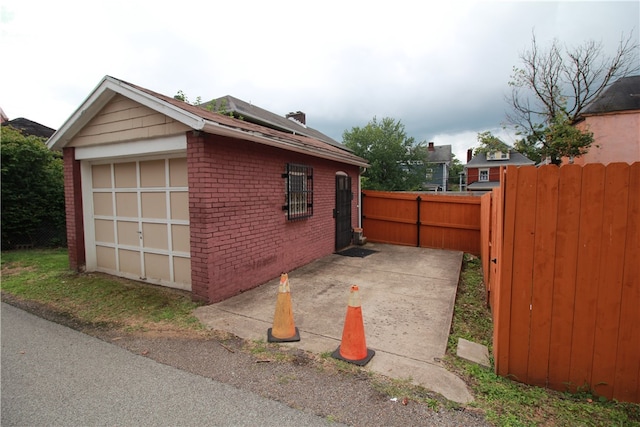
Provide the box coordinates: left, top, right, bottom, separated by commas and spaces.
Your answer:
1, 249, 204, 332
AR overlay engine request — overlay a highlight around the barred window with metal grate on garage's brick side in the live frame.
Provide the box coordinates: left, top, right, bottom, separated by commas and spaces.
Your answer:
282, 163, 313, 221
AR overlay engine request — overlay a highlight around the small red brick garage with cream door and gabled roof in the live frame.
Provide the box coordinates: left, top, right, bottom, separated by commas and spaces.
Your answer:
47, 76, 369, 302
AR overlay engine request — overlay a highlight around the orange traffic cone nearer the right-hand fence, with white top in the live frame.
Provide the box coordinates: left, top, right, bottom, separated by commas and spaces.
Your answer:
331, 285, 376, 366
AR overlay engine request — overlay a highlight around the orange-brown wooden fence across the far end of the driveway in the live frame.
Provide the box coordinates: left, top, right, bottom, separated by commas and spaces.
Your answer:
362, 190, 480, 255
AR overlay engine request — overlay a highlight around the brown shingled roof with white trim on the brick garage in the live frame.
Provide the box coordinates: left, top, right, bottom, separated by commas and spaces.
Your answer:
47, 76, 369, 167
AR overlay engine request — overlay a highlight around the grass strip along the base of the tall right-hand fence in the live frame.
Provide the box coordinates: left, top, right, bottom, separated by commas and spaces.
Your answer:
446, 254, 640, 427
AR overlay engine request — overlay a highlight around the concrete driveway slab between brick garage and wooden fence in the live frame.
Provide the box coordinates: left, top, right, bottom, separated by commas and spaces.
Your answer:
195, 243, 473, 403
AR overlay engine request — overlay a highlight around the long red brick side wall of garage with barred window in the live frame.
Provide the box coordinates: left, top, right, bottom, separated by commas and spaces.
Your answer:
187, 133, 358, 302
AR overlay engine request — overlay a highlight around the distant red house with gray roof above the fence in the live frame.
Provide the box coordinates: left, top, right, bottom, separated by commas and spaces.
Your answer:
464, 150, 535, 191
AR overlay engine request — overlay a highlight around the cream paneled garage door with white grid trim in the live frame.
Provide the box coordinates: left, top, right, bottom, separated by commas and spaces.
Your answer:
87, 158, 191, 290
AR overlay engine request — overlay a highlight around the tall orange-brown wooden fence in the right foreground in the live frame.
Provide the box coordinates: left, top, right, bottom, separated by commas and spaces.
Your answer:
488, 163, 640, 402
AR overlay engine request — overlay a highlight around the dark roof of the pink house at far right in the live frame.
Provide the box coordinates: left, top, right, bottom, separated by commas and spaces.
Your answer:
582, 76, 640, 116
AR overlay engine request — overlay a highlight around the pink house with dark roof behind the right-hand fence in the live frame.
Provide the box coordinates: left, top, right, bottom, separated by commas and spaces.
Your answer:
564, 76, 640, 165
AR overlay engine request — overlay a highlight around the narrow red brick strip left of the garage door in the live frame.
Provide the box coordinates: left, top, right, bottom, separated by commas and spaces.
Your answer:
62, 147, 86, 270
